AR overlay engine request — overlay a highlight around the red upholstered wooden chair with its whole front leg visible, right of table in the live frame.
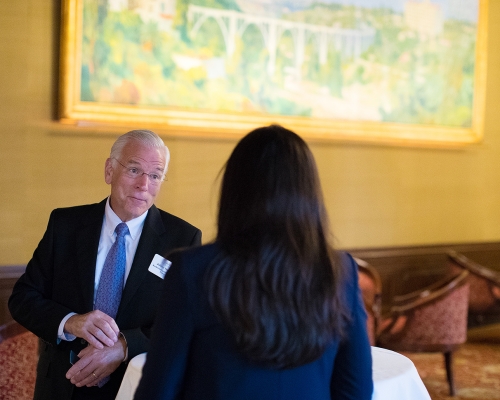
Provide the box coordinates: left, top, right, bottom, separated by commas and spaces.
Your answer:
377, 271, 469, 396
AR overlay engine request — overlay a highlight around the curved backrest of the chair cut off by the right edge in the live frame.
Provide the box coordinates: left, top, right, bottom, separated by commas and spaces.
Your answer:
448, 251, 500, 313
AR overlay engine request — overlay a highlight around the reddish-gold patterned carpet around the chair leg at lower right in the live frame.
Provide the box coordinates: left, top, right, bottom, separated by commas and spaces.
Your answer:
404, 343, 500, 400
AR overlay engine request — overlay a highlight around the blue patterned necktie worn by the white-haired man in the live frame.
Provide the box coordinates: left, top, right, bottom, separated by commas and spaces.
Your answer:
94, 222, 129, 387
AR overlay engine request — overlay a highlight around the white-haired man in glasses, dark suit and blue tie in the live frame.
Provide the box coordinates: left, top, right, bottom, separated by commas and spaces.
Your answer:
9, 130, 201, 400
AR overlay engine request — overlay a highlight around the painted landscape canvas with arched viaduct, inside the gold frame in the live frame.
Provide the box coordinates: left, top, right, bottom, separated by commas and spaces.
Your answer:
80, 0, 478, 128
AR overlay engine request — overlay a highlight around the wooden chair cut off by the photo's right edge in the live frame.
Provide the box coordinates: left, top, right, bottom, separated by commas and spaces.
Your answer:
448, 251, 500, 337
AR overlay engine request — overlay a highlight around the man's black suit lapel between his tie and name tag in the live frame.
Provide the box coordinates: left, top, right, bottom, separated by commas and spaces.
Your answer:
117, 205, 165, 318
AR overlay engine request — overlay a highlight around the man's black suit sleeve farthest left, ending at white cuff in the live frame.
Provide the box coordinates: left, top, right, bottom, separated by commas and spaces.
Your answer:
9, 211, 74, 344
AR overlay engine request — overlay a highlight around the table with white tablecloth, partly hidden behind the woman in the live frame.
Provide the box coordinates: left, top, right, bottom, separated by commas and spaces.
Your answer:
116, 347, 431, 400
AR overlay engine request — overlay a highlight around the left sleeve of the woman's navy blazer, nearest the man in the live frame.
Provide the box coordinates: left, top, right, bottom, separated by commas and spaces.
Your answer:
134, 253, 194, 400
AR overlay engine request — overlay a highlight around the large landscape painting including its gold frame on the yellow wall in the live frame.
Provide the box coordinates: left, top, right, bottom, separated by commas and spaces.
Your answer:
59, 0, 488, 146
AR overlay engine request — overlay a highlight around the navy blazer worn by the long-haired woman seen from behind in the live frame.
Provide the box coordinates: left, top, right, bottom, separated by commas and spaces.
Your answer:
135, 244, 373, 400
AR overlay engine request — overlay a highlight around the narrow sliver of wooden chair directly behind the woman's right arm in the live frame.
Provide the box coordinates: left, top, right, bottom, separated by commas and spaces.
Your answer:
354, 258, 382, 346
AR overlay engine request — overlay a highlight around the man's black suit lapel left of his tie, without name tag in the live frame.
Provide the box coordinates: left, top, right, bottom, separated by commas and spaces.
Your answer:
76, 200, 106, 311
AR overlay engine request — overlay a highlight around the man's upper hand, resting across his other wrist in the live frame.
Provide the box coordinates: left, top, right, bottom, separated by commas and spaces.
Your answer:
64, 310, 120, 349
